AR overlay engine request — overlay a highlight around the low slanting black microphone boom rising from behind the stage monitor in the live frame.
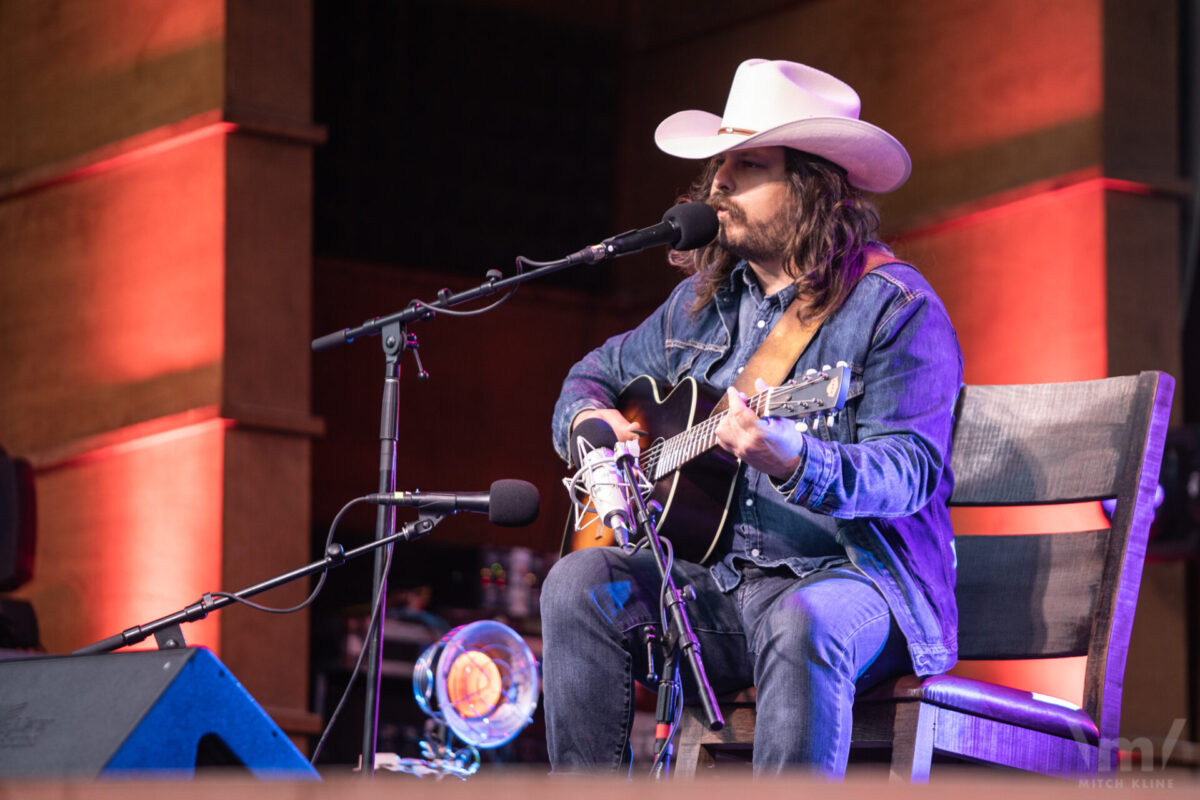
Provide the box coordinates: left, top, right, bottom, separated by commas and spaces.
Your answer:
71, 513, 445, 656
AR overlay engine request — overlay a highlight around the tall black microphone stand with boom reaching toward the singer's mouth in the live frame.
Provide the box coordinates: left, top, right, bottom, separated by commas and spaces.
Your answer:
312, 251, 624, 776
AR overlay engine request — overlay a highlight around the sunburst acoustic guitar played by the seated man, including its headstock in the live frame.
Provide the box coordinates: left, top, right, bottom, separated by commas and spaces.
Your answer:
562, 366, 850, 564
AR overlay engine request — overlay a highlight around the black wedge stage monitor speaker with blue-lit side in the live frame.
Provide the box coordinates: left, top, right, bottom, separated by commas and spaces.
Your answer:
0, 648, 318, 780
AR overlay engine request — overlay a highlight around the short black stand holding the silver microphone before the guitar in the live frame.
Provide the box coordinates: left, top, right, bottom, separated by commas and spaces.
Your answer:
617, 451, 725, 778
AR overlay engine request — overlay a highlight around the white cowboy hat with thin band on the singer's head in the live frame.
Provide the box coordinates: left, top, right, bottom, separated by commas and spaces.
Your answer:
654, 59, 912, 192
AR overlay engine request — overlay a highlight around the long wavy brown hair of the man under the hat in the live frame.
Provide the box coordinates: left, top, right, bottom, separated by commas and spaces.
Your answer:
668, 148, 880, 319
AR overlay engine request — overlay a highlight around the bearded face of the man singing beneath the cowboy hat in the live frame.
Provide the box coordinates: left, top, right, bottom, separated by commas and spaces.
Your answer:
708, 148, 796, 266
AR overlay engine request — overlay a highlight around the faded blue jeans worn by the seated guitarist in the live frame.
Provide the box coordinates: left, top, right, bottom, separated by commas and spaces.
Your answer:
541, 547, 912, 777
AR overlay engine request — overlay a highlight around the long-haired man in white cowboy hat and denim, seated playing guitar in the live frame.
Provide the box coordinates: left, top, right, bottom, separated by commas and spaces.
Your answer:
541, 59, 962, 775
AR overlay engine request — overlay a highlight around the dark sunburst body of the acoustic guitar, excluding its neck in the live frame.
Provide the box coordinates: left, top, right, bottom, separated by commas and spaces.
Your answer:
562, 375, 738, 563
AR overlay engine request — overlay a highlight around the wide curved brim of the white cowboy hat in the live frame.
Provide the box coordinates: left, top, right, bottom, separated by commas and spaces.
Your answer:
654, 110, 912, 193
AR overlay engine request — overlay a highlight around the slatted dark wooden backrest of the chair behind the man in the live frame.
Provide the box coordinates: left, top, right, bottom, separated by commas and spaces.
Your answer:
950, 372, 1175, 736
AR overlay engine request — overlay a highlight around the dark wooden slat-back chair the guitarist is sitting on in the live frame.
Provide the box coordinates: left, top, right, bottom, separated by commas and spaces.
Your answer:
676, 372, 1175, 781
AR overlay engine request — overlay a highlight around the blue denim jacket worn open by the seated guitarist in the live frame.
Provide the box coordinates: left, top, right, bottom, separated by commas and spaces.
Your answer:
553, 263, 962, 675
